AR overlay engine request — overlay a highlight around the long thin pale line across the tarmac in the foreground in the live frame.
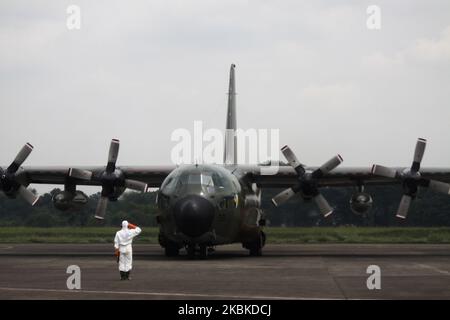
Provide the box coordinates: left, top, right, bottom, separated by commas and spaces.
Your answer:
0, 287, 343, 300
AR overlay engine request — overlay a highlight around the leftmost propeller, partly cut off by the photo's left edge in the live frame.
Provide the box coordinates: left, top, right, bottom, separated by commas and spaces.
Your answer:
0, 143, 39, 206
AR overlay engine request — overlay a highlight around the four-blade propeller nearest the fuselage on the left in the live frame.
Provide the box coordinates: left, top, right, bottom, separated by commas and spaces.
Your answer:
68, 139, 147, 220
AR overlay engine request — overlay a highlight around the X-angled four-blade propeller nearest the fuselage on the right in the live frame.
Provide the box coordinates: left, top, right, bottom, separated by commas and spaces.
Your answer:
272, 146, 343, 217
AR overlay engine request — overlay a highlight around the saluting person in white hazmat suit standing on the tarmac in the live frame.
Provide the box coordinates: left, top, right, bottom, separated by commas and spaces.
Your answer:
114, 220, 142, 280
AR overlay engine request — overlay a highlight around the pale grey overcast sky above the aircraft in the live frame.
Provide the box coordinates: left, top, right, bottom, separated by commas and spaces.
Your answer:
0, 0, 450, 192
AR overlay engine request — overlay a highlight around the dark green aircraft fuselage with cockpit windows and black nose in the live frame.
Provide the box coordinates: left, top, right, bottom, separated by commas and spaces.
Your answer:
157, 164, 264, 255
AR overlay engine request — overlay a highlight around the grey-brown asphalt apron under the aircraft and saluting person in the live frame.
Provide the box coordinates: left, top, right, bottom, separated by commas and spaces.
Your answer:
0, 244, 450, 299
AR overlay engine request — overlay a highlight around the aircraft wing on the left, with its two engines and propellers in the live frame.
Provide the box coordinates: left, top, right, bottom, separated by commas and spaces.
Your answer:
0, 164, 175, 219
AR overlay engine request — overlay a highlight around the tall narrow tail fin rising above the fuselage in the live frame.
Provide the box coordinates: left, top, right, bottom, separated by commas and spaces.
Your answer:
223, 64, 237, 164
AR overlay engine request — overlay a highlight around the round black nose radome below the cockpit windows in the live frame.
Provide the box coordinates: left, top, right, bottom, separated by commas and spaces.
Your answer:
173, 195, 214, 237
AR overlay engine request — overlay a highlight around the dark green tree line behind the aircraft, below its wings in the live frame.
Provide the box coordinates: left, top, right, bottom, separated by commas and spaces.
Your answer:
0, 186, 450, 227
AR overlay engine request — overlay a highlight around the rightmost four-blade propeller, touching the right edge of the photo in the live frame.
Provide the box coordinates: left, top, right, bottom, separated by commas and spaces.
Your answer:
372, 138, 450, 219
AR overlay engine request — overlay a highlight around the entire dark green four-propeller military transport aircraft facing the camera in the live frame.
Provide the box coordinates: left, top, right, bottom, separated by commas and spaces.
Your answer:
0, 64, 450, 257
